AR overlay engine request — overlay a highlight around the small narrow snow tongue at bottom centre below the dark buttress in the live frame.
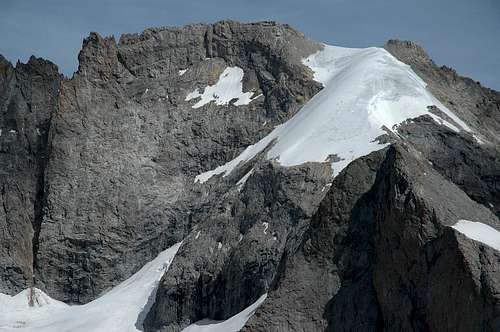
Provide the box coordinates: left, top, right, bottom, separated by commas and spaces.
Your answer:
182, 294, 267, 332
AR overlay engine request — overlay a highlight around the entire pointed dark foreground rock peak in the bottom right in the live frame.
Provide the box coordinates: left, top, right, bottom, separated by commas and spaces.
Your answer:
245, 145, 500, 331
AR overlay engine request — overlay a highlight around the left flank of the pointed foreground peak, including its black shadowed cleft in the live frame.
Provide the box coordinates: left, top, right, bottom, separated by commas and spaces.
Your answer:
243, 150, 385, 331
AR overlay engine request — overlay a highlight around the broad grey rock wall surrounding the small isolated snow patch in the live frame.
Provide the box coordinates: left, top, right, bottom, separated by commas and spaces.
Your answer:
36, 22, 319, 303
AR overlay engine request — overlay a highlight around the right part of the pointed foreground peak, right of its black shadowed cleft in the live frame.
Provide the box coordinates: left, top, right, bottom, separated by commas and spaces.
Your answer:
373, 145, 500, 331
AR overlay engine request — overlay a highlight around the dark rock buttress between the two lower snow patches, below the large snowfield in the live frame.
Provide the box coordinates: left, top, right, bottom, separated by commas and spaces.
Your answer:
146, 162, 331, 331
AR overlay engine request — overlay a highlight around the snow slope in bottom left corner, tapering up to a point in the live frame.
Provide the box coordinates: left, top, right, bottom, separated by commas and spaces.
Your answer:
0, 243, 181, 332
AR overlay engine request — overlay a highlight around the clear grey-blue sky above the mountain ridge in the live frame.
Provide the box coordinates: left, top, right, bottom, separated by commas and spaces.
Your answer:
0, 0, 500, 90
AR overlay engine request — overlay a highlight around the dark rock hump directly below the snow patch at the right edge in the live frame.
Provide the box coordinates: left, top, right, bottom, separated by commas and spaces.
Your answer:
425, 228, 500, 332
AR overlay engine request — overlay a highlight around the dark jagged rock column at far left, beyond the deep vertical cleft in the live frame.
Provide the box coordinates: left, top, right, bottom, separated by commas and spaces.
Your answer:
0, 56, 62, 294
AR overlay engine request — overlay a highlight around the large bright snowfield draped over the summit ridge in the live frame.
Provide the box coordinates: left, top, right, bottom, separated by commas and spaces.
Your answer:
195, 45, 470, 182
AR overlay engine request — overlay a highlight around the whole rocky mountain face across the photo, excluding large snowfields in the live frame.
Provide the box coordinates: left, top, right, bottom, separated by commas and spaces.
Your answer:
0, 21, 500, 332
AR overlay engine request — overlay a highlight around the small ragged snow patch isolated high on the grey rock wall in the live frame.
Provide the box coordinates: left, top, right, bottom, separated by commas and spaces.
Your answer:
186, 67, 259, 108
